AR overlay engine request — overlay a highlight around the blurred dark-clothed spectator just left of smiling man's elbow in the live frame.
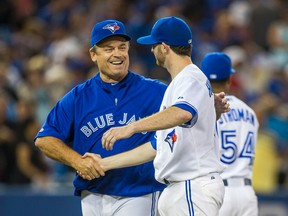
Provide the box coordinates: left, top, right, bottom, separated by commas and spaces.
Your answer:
11, 100, 51, 190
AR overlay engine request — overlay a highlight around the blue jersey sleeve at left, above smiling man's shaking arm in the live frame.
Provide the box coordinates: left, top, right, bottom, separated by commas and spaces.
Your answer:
35, 90, 75, 143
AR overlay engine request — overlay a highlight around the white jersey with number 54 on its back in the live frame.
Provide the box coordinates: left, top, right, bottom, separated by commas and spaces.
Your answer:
217, 95, 259, 179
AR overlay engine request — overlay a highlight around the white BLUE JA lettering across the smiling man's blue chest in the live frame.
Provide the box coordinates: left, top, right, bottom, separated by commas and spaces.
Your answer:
80, 113, 140, 137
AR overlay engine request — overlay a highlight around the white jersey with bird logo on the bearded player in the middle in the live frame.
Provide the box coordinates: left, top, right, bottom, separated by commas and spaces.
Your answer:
154, 64, 223, 182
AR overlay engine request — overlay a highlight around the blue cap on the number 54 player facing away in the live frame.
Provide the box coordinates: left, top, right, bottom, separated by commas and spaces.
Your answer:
201, 52, 235, 80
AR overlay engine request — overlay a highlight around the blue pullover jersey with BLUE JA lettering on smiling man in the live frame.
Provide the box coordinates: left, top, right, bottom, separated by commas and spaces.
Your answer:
36, 71, 167, 197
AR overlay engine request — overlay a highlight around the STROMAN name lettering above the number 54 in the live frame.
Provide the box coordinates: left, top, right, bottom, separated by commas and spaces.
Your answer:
218, 108, 255, 125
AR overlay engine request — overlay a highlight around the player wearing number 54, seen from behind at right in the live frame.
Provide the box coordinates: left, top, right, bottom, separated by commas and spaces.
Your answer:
201, 52, 259, 216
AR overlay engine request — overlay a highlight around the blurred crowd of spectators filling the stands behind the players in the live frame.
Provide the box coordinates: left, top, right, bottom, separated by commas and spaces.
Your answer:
0, 0, 288, 193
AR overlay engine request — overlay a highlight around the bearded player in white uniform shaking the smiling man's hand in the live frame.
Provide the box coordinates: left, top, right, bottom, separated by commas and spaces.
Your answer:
102, 17, 224, 216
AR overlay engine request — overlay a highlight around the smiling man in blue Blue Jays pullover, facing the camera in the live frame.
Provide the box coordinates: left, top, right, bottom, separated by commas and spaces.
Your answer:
35, 20, 167, 216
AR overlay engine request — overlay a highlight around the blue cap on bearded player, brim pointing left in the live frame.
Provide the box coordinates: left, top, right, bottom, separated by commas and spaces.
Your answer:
137, 16, 192, 46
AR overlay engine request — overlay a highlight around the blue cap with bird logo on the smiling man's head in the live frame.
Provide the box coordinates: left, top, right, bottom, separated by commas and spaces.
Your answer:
91, 20, 131, 47
